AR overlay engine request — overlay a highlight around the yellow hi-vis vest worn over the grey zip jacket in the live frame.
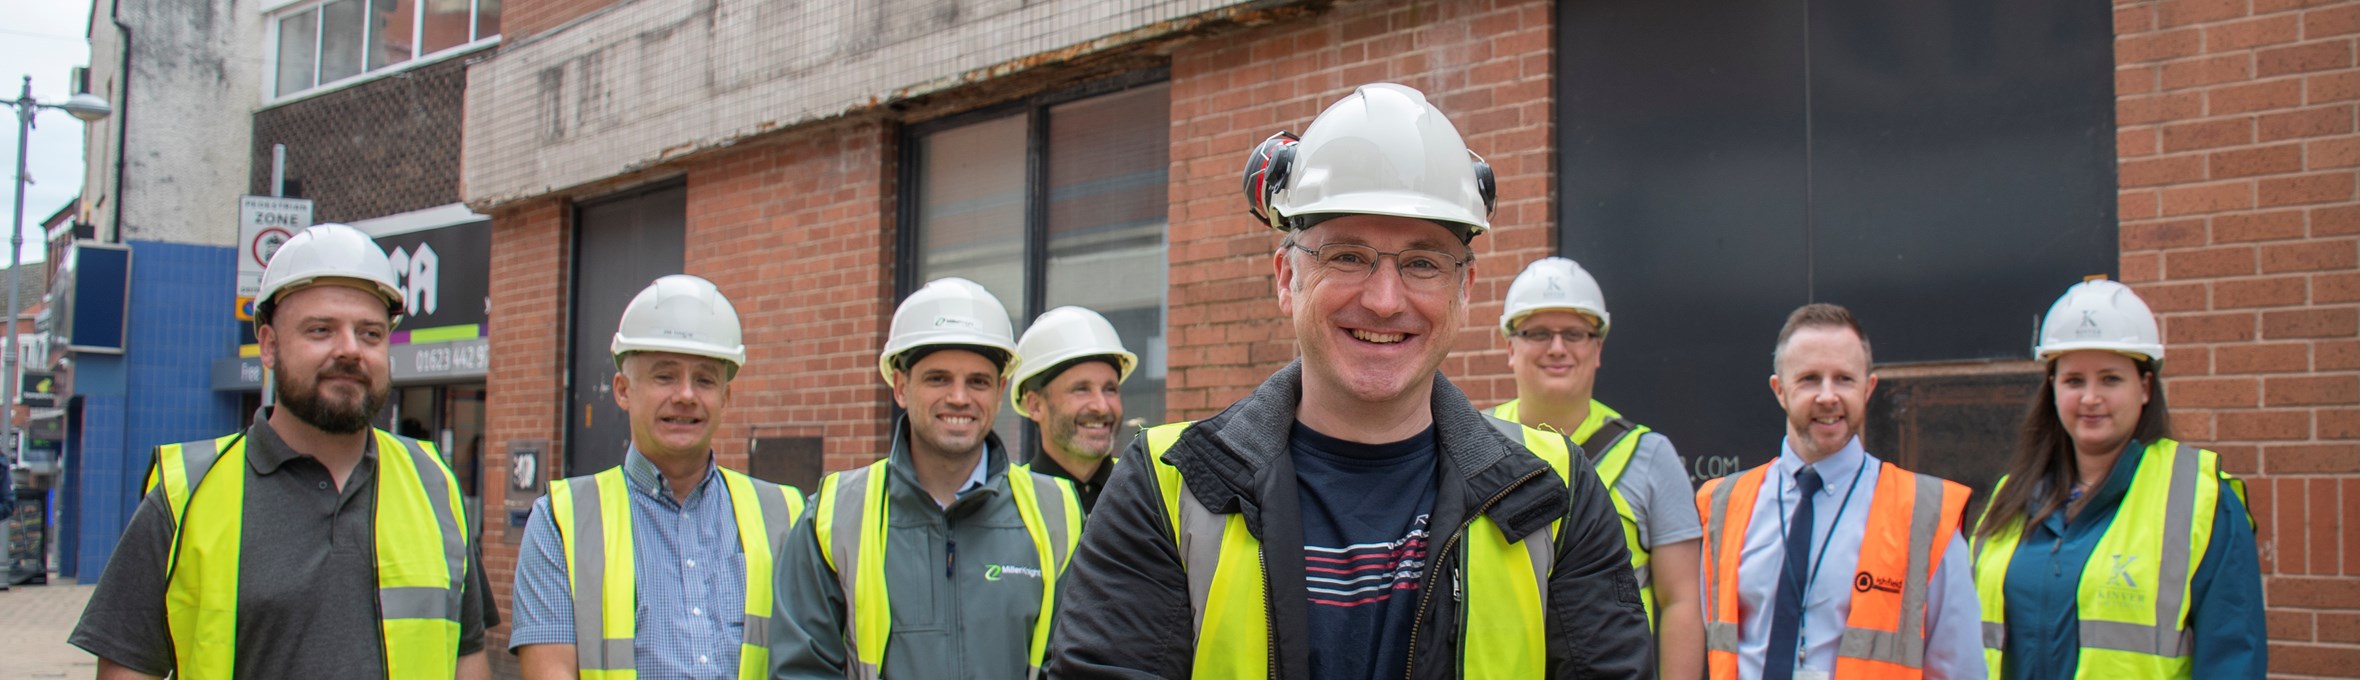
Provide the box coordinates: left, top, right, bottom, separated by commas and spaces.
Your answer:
812, 458, 1081, 680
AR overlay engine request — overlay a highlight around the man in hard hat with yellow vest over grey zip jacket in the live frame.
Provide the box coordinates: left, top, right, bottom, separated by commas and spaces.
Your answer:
769, 276, 1081, 678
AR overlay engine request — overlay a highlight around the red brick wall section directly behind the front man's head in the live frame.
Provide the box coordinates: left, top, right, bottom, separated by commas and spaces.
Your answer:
1166, 0, 1555, 420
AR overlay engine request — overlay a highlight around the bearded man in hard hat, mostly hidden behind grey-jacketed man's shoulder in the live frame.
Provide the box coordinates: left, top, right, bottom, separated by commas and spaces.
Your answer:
1008, 307, 1140, 512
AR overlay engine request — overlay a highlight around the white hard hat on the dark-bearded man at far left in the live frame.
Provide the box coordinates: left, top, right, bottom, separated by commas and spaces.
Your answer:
255, 222, 408, 326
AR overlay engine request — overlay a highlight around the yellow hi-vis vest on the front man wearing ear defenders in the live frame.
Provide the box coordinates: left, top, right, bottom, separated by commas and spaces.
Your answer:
1145, 420, 1576, 680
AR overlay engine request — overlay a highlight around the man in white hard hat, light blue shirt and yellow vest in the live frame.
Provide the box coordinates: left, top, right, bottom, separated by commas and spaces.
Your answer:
507, 274, 802, 680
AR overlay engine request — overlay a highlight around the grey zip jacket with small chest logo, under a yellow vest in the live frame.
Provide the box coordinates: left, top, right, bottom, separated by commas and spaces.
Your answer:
769, 418, 1071, 680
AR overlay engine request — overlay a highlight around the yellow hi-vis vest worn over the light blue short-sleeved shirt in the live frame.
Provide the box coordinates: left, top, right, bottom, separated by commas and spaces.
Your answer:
550, 465, 802, 680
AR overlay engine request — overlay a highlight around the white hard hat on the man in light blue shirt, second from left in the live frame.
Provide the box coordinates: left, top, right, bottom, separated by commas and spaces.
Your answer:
607, 274, 746, 378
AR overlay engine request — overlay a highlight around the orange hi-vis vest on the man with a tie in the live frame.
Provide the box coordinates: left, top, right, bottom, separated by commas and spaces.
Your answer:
1697, 460, 1968, 680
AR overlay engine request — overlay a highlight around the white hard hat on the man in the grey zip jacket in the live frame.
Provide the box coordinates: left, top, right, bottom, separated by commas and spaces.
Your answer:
878, 276, 1020, 385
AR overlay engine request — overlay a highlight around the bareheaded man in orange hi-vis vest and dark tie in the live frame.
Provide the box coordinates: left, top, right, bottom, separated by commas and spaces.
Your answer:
1697, 305, 1985, 680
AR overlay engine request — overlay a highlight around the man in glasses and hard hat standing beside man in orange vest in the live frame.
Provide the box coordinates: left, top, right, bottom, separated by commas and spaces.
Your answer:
1489, 257, 1704, 678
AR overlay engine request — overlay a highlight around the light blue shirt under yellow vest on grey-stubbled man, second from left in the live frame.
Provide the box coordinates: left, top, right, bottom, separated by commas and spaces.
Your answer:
507, 446, 746, 680
